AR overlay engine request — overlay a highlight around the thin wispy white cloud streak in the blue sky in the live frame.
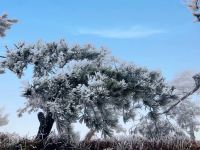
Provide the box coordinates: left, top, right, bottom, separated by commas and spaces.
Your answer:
78, 26, 167, 39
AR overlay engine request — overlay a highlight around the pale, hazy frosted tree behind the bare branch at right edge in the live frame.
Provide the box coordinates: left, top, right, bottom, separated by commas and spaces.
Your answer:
171, 71, 200, 141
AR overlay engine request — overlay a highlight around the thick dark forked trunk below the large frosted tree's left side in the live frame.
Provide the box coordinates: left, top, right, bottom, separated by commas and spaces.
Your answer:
35, 112, 54, 141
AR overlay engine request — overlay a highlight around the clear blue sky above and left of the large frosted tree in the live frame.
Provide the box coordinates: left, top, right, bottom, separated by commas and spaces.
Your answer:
0, 0, 200, 138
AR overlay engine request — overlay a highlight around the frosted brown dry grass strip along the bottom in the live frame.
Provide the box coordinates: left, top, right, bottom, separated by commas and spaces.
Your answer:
0, 133, 200, 150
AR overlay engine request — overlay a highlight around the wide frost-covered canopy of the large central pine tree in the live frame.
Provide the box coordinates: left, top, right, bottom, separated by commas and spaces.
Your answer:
0, 40, 200, 139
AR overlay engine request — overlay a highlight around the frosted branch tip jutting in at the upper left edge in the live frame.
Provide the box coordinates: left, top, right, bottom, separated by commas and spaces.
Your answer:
0, 14, 17, 37
